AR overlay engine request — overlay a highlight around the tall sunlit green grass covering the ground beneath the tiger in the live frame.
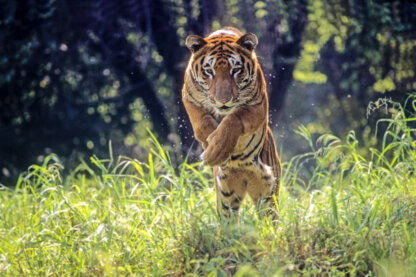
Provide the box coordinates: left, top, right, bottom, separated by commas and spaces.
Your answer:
0, 98, 416, 276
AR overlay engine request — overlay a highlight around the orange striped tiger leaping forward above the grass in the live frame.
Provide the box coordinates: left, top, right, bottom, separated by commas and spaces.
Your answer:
182, 27, 282, 220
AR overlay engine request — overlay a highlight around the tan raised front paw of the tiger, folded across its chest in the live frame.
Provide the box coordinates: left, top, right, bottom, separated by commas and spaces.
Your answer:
201, 126, 238, 166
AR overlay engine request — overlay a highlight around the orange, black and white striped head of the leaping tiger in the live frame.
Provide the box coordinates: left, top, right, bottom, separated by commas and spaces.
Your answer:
186, 30, 258, 114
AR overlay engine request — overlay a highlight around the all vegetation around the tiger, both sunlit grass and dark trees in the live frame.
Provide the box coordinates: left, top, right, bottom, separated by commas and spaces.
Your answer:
0, 0, 416, 276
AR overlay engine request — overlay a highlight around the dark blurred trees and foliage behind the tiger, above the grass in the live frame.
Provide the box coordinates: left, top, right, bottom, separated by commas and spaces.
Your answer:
0, 0, 416, 183
